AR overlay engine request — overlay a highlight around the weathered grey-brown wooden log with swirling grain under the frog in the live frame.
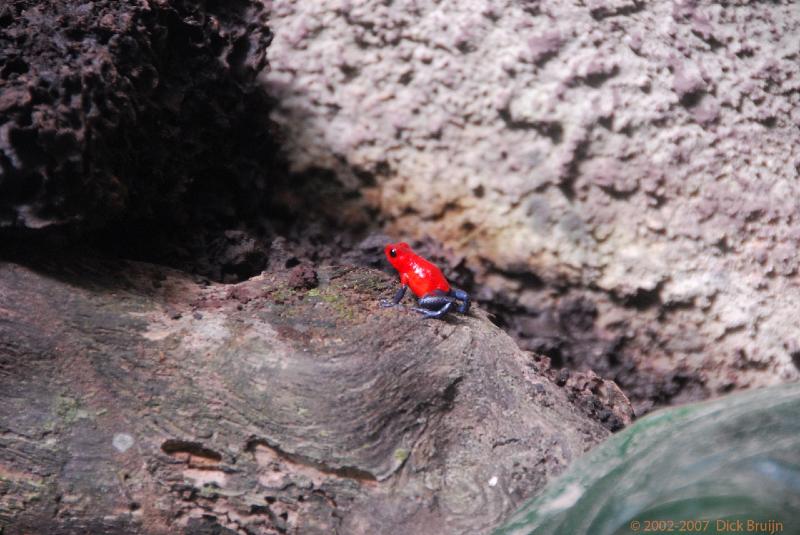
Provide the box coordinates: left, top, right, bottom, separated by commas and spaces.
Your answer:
0, 260, 608, 535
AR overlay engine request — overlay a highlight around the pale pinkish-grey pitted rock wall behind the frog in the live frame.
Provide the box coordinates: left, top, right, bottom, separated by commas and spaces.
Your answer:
263, 0, 800, 412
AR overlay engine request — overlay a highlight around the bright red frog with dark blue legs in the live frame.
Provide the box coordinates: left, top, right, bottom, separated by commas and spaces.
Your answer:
381, 242, 469, 318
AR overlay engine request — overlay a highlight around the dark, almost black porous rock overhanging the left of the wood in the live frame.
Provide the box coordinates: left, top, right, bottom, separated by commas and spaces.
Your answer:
0, 0, 275, 230
